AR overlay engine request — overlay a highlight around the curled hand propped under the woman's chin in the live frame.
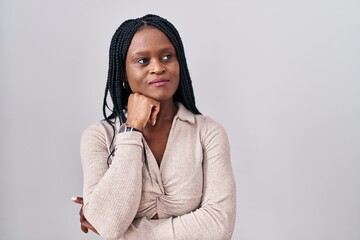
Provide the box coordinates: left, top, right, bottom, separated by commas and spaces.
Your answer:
126, 93, 160, 132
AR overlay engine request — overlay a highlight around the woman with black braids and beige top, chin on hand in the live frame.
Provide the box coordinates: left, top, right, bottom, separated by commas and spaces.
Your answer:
75, 15, 236, 240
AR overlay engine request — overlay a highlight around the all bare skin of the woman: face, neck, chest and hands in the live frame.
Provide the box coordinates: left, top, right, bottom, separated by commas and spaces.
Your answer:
72, 26, 180, 234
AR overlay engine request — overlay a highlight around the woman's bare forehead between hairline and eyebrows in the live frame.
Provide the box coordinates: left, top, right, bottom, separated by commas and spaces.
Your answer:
128, 27, 174, 53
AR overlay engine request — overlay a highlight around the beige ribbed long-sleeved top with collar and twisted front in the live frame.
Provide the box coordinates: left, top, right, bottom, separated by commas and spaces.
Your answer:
80, 103, 236, 240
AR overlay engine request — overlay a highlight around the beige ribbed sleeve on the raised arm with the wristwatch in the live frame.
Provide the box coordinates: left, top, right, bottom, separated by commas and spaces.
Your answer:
80, 123, 143, 239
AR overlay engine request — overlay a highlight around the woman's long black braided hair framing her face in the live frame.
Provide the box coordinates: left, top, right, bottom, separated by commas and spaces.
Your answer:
103, 14, 201, 166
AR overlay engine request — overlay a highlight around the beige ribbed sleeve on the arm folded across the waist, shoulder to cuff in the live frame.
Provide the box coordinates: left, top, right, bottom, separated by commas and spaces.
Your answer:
122, 118, 236, 240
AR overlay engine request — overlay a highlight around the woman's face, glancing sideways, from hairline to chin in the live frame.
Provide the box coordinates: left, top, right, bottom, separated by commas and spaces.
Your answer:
125, 27, 180, 102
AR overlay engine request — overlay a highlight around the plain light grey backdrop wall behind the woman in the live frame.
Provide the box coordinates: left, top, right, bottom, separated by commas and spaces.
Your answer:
0, 0, 360, 240
